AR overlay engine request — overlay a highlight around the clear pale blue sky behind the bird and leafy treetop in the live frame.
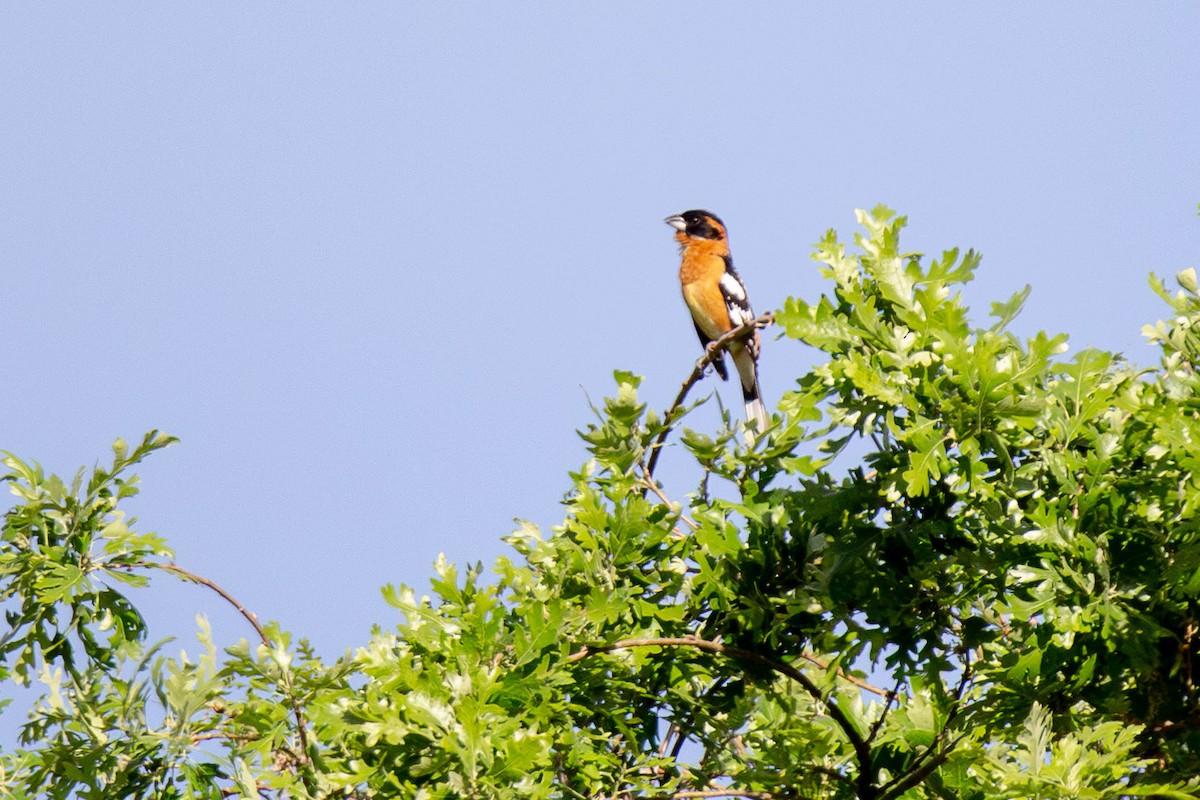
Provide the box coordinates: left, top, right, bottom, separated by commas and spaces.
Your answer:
0, 2, 1200, 714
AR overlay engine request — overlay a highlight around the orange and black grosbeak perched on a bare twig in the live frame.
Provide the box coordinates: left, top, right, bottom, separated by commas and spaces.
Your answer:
665, 209, 769, 432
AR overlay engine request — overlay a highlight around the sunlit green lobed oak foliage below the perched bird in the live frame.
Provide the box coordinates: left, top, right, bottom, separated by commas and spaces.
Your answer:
0, 207, 1200, 800
